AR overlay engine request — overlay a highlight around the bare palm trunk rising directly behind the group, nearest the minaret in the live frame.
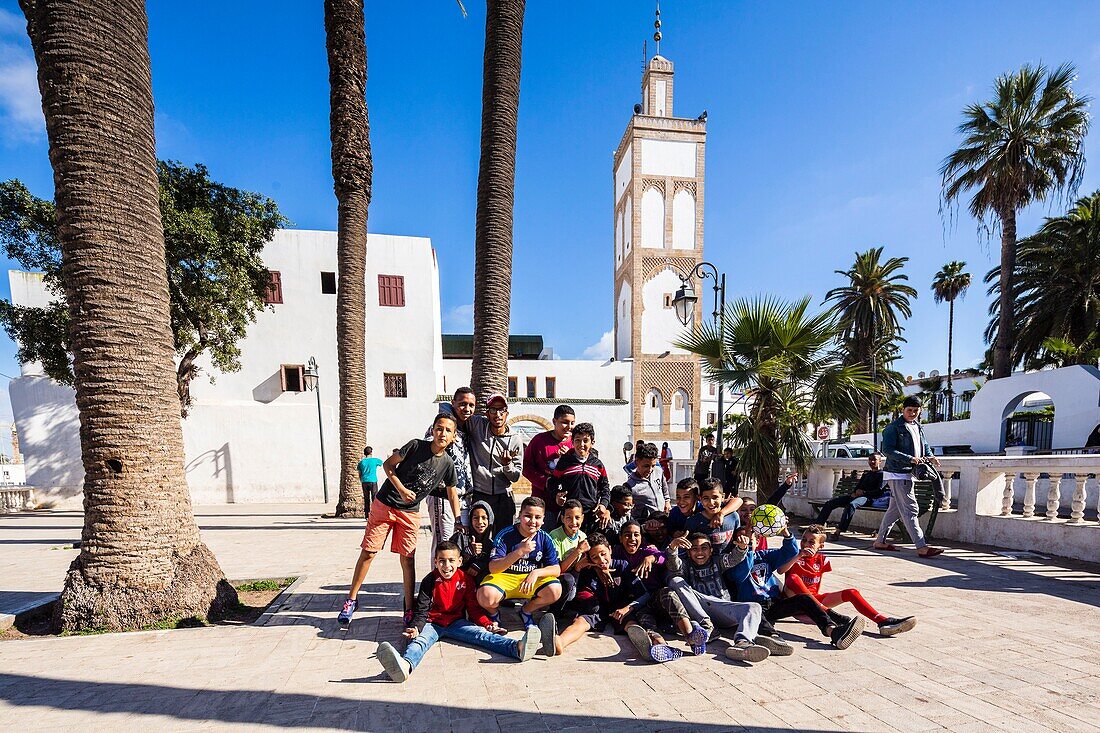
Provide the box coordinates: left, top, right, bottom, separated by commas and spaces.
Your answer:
471, 0, 525, 404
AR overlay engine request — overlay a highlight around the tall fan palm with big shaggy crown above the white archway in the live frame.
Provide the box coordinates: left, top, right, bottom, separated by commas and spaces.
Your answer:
939, 64, 1090, 379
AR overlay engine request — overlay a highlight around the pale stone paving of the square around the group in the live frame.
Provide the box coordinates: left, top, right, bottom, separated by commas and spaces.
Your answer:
0, 504, 1100, 733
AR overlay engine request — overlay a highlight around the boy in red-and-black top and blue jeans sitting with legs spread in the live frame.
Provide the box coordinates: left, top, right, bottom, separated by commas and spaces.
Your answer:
378, 541, 541, 682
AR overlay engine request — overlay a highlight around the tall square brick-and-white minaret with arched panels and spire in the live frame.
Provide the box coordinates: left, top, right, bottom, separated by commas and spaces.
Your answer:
614, 11, 706, 458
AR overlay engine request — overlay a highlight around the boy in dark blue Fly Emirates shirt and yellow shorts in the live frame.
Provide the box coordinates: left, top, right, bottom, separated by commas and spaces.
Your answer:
477, 496, 561, 653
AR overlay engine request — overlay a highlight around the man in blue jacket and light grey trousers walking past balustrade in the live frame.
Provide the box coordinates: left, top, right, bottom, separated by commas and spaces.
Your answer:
873, 396, 944, 557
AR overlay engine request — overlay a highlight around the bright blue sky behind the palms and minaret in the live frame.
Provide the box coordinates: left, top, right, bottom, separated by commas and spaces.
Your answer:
0, 0, 1100, 419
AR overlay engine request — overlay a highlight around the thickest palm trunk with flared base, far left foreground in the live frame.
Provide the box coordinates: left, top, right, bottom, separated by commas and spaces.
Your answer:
20, 0, 237, 631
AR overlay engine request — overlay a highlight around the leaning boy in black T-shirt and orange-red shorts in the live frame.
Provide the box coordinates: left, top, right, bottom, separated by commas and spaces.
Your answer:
338, 413, 459, 627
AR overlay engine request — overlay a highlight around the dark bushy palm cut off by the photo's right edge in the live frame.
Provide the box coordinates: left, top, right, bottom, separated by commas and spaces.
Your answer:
986, 190, 1100, 369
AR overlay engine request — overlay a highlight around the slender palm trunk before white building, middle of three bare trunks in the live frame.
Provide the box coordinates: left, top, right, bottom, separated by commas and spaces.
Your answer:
325, 0, 374, 516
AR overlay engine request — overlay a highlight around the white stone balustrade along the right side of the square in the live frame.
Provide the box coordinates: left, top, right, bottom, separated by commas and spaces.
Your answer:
787, 455, 1100, 560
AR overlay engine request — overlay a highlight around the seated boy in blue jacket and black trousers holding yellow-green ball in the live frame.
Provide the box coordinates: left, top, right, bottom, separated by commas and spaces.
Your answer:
728, 525, 865, 649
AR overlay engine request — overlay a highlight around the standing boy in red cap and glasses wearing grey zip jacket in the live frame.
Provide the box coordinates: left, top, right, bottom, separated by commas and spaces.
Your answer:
465, 394, 524, 530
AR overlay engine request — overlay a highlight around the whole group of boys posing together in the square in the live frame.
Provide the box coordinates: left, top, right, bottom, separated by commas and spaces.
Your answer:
339, 389, 915, 681
